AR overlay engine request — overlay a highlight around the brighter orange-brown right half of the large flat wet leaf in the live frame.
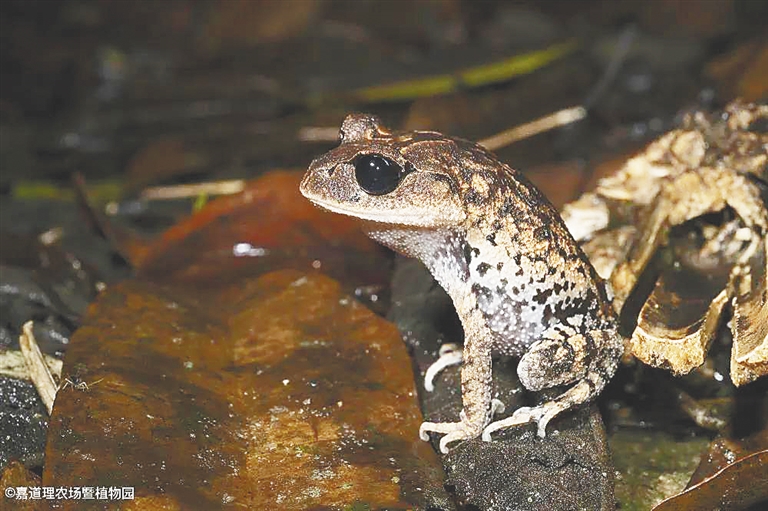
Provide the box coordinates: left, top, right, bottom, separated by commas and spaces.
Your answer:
230, 272, 448, 509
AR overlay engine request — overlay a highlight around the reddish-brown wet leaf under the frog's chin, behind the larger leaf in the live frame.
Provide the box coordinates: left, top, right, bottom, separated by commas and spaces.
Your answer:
123, 171, 388, 294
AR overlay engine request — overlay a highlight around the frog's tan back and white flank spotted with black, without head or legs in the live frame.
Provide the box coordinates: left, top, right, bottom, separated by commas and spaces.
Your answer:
440, 141, 613, 355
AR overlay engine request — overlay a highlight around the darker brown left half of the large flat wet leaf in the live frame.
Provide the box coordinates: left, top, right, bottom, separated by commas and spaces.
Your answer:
43, 281, 242, 509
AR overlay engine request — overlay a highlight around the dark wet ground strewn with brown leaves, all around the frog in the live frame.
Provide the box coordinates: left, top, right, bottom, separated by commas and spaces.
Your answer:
0, 0, 768, 509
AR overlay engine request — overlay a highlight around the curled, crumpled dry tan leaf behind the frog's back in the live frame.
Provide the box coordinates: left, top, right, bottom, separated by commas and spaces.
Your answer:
563, 102, 768, 386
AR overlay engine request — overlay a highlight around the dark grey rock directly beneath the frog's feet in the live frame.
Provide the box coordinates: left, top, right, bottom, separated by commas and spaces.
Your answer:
443, 405, 615, 511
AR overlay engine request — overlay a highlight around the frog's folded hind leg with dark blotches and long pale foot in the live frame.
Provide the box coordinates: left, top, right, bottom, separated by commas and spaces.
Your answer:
483, 326, 624, 442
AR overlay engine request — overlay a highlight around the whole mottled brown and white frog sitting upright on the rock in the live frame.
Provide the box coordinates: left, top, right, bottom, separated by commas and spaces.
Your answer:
299, 113, 624, 453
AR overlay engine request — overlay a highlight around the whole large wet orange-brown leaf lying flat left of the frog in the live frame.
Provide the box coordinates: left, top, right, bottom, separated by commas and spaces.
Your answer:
43, 270, 450, 510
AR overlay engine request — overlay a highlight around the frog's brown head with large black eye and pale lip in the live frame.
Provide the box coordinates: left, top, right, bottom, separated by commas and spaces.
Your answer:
300, 114, 474, 228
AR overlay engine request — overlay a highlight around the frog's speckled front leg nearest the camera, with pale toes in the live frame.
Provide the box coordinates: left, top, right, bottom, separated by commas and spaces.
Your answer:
419, 329, 504, 454
